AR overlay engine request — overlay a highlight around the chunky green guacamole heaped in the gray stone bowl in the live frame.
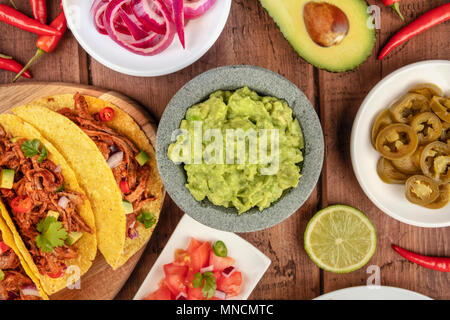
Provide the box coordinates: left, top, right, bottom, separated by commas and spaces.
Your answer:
168, 87, 304, 214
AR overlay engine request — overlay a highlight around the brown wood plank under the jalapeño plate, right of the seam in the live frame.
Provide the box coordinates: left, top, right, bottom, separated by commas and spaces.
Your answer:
319, 0, 450, 299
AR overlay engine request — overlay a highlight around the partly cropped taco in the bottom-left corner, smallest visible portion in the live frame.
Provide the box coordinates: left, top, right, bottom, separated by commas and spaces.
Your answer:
0, 212, 48, 300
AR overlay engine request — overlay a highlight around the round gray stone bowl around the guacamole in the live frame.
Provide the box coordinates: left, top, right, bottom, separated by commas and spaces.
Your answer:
156, 65, 324, 232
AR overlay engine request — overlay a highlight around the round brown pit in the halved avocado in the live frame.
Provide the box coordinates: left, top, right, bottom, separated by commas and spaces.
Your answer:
303, 1, 350, 47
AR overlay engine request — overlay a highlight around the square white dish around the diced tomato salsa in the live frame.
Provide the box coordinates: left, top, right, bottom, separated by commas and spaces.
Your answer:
134, 214, 271, 300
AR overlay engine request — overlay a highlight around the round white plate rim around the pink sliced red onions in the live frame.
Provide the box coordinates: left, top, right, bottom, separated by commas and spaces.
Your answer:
62, 0, 231, 77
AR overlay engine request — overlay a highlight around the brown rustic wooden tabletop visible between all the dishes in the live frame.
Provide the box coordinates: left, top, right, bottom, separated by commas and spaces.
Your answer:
0, 0, 450, 299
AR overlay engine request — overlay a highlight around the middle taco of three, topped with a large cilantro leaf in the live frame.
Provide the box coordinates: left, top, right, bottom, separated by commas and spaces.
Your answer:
0, 114, 97, 295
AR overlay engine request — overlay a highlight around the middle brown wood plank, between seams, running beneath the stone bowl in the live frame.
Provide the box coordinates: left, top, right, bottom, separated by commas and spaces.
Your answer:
112, 0, 320, 299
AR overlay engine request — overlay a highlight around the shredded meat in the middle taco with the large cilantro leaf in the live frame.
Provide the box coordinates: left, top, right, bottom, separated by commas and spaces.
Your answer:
0, 126, 93, 274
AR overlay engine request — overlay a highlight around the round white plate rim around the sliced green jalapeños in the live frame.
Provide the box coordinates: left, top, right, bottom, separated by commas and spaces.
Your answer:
350, 60, 450, 228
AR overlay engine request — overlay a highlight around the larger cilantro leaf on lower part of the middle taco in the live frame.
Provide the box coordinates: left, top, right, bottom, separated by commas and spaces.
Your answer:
36, 216, 67, 253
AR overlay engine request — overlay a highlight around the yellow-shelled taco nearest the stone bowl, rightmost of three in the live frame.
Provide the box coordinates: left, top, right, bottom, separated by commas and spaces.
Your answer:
13, 93, 163, 269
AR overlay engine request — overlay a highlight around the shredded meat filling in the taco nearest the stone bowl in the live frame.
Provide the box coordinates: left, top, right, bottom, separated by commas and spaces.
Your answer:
58, 93, 155, 236
